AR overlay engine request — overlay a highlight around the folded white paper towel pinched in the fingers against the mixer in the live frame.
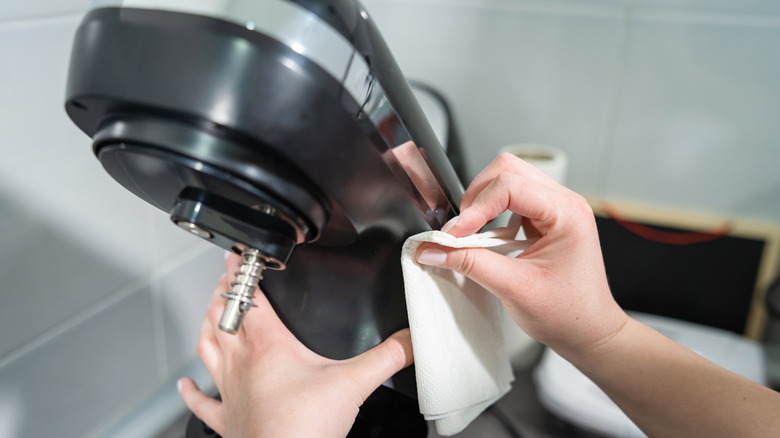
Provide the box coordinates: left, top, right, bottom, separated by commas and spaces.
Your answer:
401, 228, 527, 435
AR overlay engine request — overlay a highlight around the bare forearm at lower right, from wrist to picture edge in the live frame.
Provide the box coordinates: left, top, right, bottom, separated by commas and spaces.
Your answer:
560, 320, 780, 437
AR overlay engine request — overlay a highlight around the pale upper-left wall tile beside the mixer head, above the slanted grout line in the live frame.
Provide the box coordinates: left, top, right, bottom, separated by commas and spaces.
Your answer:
0, 18, 158, 274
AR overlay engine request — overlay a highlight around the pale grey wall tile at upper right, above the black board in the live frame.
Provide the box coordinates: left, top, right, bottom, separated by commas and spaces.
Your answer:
604, 8, 780, 219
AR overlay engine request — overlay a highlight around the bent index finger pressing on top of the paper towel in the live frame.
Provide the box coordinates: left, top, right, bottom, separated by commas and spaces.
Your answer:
446, 172, 565, 237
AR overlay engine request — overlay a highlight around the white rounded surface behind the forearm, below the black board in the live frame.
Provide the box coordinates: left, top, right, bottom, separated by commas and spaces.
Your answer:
534, 313, 766, 437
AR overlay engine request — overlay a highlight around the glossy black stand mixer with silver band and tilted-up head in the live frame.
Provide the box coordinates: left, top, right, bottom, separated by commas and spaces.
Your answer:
65, 0, 463, 436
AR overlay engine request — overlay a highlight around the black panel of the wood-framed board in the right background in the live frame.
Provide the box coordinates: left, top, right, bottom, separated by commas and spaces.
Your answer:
596, 216, 765, 334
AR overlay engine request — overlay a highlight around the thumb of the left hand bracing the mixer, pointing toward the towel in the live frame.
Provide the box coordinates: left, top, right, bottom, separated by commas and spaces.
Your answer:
344, 329, 414, 400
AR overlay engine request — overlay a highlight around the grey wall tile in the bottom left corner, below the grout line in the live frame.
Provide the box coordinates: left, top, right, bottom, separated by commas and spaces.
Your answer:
0, 287, 157, 438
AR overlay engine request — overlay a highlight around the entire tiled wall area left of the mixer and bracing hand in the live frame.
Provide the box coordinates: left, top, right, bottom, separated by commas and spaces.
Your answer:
0, 1, 229, 438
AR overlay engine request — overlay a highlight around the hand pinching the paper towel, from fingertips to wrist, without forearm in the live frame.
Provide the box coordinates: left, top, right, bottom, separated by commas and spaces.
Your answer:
417, 154, 628, 354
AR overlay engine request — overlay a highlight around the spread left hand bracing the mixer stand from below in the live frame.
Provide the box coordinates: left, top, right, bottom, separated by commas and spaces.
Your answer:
179, 256, 412, 438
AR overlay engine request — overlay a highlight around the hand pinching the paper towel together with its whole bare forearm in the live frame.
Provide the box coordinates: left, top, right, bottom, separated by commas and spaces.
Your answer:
424, 154, 780, 437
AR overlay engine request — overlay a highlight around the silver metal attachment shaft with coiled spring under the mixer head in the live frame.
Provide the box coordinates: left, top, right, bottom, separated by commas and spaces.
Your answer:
219, 248, 267, 333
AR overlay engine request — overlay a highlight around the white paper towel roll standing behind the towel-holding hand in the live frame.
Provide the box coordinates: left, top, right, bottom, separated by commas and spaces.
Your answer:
491, 143, 568, 368
